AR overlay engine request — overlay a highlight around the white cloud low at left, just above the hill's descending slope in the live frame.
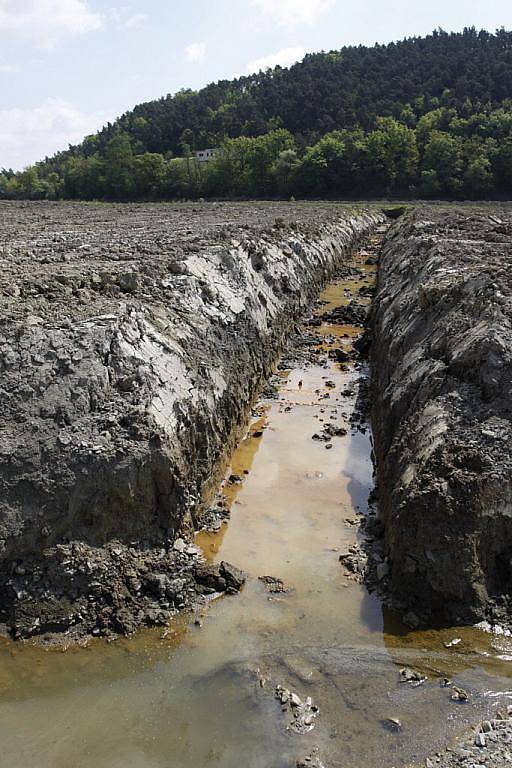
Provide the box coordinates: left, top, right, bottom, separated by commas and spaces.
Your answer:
0, 99, 112, 170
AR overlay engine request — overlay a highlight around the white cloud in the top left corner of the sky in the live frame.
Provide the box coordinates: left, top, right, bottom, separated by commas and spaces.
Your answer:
0, 0, 104, 47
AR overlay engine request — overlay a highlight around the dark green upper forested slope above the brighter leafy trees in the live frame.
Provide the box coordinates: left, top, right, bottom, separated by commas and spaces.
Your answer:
76, 30, 512, 154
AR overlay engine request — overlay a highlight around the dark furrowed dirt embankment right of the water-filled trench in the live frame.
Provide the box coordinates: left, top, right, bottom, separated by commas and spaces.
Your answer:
372, 206, 512, 626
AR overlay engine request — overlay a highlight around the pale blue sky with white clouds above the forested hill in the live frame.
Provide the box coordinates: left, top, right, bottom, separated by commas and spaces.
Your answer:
0, 0, 512, 170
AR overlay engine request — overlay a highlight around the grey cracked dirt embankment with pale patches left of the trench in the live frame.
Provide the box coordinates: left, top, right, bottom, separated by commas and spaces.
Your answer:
0, 204, 382, 637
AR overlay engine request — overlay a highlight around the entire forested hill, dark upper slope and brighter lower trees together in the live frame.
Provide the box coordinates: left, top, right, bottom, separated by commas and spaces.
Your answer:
0, 29, 512, 199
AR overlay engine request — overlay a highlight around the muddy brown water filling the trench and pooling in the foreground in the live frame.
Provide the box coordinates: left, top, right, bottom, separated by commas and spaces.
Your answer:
0, 236, 512, 768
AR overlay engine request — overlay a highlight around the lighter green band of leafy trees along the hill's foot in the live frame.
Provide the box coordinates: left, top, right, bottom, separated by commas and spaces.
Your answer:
4, 102, 512, 200
